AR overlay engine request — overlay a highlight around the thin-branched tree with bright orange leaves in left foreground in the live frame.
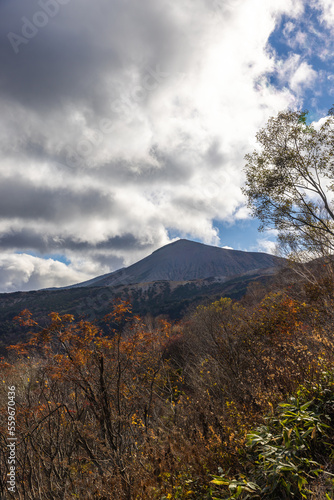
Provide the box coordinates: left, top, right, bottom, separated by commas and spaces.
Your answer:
0, 301, 174, 500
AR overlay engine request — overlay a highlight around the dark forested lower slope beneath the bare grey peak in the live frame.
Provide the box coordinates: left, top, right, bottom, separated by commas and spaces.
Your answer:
0, 268, 275, 356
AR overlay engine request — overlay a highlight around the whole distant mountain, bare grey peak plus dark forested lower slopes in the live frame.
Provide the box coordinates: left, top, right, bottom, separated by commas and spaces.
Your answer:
0, 240, 284, 355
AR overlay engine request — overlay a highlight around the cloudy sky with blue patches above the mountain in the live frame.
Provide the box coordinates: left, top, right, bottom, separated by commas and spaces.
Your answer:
0, 0, 334, 292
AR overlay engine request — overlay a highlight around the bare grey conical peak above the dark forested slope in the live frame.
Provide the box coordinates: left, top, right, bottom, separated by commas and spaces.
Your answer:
66, 239, 282, 288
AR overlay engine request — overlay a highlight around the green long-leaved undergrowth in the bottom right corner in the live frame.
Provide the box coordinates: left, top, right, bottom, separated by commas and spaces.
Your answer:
212, 372, 334, 500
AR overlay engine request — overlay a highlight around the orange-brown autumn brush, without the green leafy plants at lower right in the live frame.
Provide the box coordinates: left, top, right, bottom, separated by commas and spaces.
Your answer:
0, 293, 330, 500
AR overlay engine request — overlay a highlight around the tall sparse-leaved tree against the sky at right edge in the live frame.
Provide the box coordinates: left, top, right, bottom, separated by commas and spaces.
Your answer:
243, 111, 334, 258
